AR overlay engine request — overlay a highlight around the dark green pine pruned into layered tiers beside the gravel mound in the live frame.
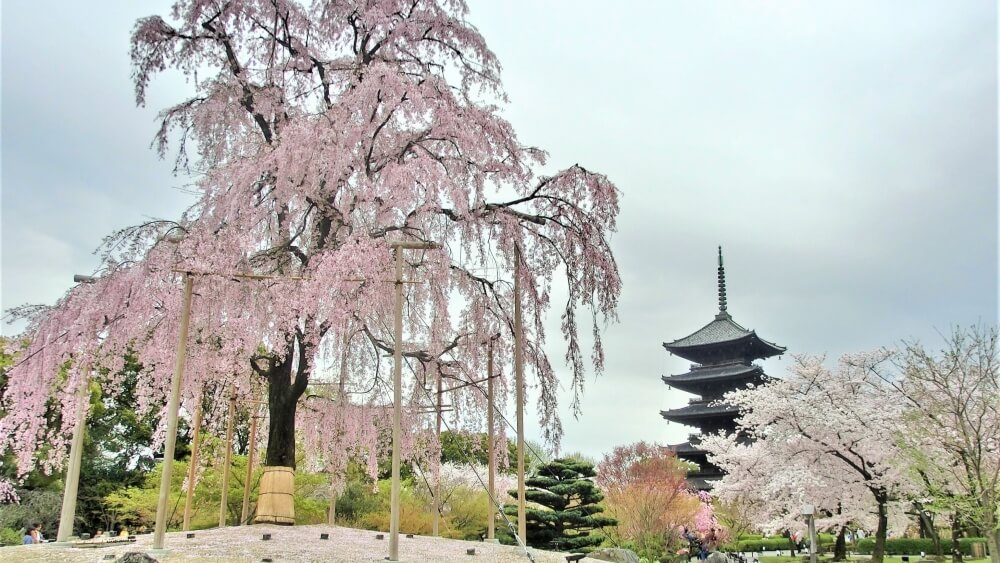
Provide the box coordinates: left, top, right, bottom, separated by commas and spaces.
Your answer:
504, 459, 617, 551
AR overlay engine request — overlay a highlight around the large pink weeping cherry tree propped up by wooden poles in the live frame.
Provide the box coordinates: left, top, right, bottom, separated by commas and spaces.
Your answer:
2, 0, 621, 524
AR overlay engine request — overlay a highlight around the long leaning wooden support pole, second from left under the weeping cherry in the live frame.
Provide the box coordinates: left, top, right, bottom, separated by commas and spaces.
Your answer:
153, 274, 194, 549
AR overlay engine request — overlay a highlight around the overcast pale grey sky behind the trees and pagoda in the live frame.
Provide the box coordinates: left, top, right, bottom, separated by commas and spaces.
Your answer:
0, 0, 998, 457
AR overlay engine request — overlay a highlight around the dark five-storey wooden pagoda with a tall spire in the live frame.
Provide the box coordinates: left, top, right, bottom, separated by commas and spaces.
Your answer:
660, 246, 785, 491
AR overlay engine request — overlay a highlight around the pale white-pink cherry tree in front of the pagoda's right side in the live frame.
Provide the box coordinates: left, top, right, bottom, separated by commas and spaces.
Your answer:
703, 353, 911, 563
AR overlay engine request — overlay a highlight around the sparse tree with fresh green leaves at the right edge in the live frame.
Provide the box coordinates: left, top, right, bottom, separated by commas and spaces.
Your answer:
883, 326, 1000, 563
